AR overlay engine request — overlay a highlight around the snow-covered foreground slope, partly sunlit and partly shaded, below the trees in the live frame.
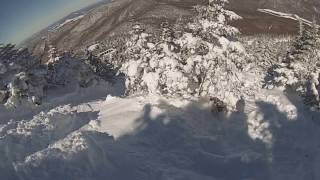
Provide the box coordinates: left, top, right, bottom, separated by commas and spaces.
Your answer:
0, 75, 320, 180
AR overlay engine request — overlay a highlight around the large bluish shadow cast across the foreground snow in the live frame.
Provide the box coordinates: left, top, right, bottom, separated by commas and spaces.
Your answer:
14, 90, 320, 180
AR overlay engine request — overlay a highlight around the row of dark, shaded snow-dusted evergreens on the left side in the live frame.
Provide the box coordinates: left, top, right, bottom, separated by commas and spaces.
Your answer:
0, 44, 101, 108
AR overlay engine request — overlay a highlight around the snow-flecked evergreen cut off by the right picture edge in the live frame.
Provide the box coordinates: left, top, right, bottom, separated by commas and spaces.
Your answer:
268, 22, 320, 106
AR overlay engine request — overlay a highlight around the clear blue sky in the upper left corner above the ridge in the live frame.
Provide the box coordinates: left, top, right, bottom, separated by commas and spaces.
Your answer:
0, 0, 100, 44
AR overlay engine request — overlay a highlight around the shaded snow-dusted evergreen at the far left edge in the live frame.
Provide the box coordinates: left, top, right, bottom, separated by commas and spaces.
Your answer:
0, 44, 46, 107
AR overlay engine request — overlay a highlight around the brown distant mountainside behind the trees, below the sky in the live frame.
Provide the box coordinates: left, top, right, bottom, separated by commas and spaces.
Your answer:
25, 0, 320, 56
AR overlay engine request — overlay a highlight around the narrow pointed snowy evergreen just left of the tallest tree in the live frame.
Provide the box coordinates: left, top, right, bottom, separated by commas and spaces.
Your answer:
142, 22, 188, 96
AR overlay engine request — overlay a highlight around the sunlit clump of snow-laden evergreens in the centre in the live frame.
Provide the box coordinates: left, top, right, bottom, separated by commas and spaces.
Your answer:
122, 0, 251, 108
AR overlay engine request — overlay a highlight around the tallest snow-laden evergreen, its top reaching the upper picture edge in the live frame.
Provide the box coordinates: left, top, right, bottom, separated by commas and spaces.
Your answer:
176, 0, 246, 106
